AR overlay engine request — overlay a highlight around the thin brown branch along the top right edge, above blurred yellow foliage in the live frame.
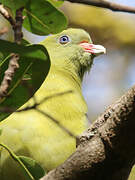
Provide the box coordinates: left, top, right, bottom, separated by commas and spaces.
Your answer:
66, 0, 135, 13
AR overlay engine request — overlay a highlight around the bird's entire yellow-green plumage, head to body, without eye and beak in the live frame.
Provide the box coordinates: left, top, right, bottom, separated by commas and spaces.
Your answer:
0, 29, 96, 180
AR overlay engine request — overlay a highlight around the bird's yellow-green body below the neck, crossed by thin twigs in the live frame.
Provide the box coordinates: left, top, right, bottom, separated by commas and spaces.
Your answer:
0, 68, 87, 180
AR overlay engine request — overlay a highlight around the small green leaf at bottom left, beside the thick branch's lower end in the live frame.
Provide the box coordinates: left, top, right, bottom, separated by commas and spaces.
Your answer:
18, 156, 45, 180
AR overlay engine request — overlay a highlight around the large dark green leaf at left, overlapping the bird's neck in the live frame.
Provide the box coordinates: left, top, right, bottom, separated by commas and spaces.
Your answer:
0, 40, 50, 121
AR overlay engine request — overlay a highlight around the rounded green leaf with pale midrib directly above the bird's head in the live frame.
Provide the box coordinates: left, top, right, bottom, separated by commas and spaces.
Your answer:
23, 0, 67, 35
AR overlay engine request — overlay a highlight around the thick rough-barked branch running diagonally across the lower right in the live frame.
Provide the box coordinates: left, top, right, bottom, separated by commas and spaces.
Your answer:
44, 86, 135, 180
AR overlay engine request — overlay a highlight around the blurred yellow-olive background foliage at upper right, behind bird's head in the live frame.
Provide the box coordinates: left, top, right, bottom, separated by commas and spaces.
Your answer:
62, 2, 135, 49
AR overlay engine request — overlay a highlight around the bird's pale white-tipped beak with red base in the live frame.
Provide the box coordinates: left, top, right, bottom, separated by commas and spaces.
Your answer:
80, 42, 106, 55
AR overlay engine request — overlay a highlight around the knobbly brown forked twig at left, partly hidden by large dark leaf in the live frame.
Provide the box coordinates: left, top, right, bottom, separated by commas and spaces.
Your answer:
0, 4, 23, 100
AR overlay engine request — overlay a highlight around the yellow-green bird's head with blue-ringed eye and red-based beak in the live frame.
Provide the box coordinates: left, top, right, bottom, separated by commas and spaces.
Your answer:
41, 28, 106, 79
